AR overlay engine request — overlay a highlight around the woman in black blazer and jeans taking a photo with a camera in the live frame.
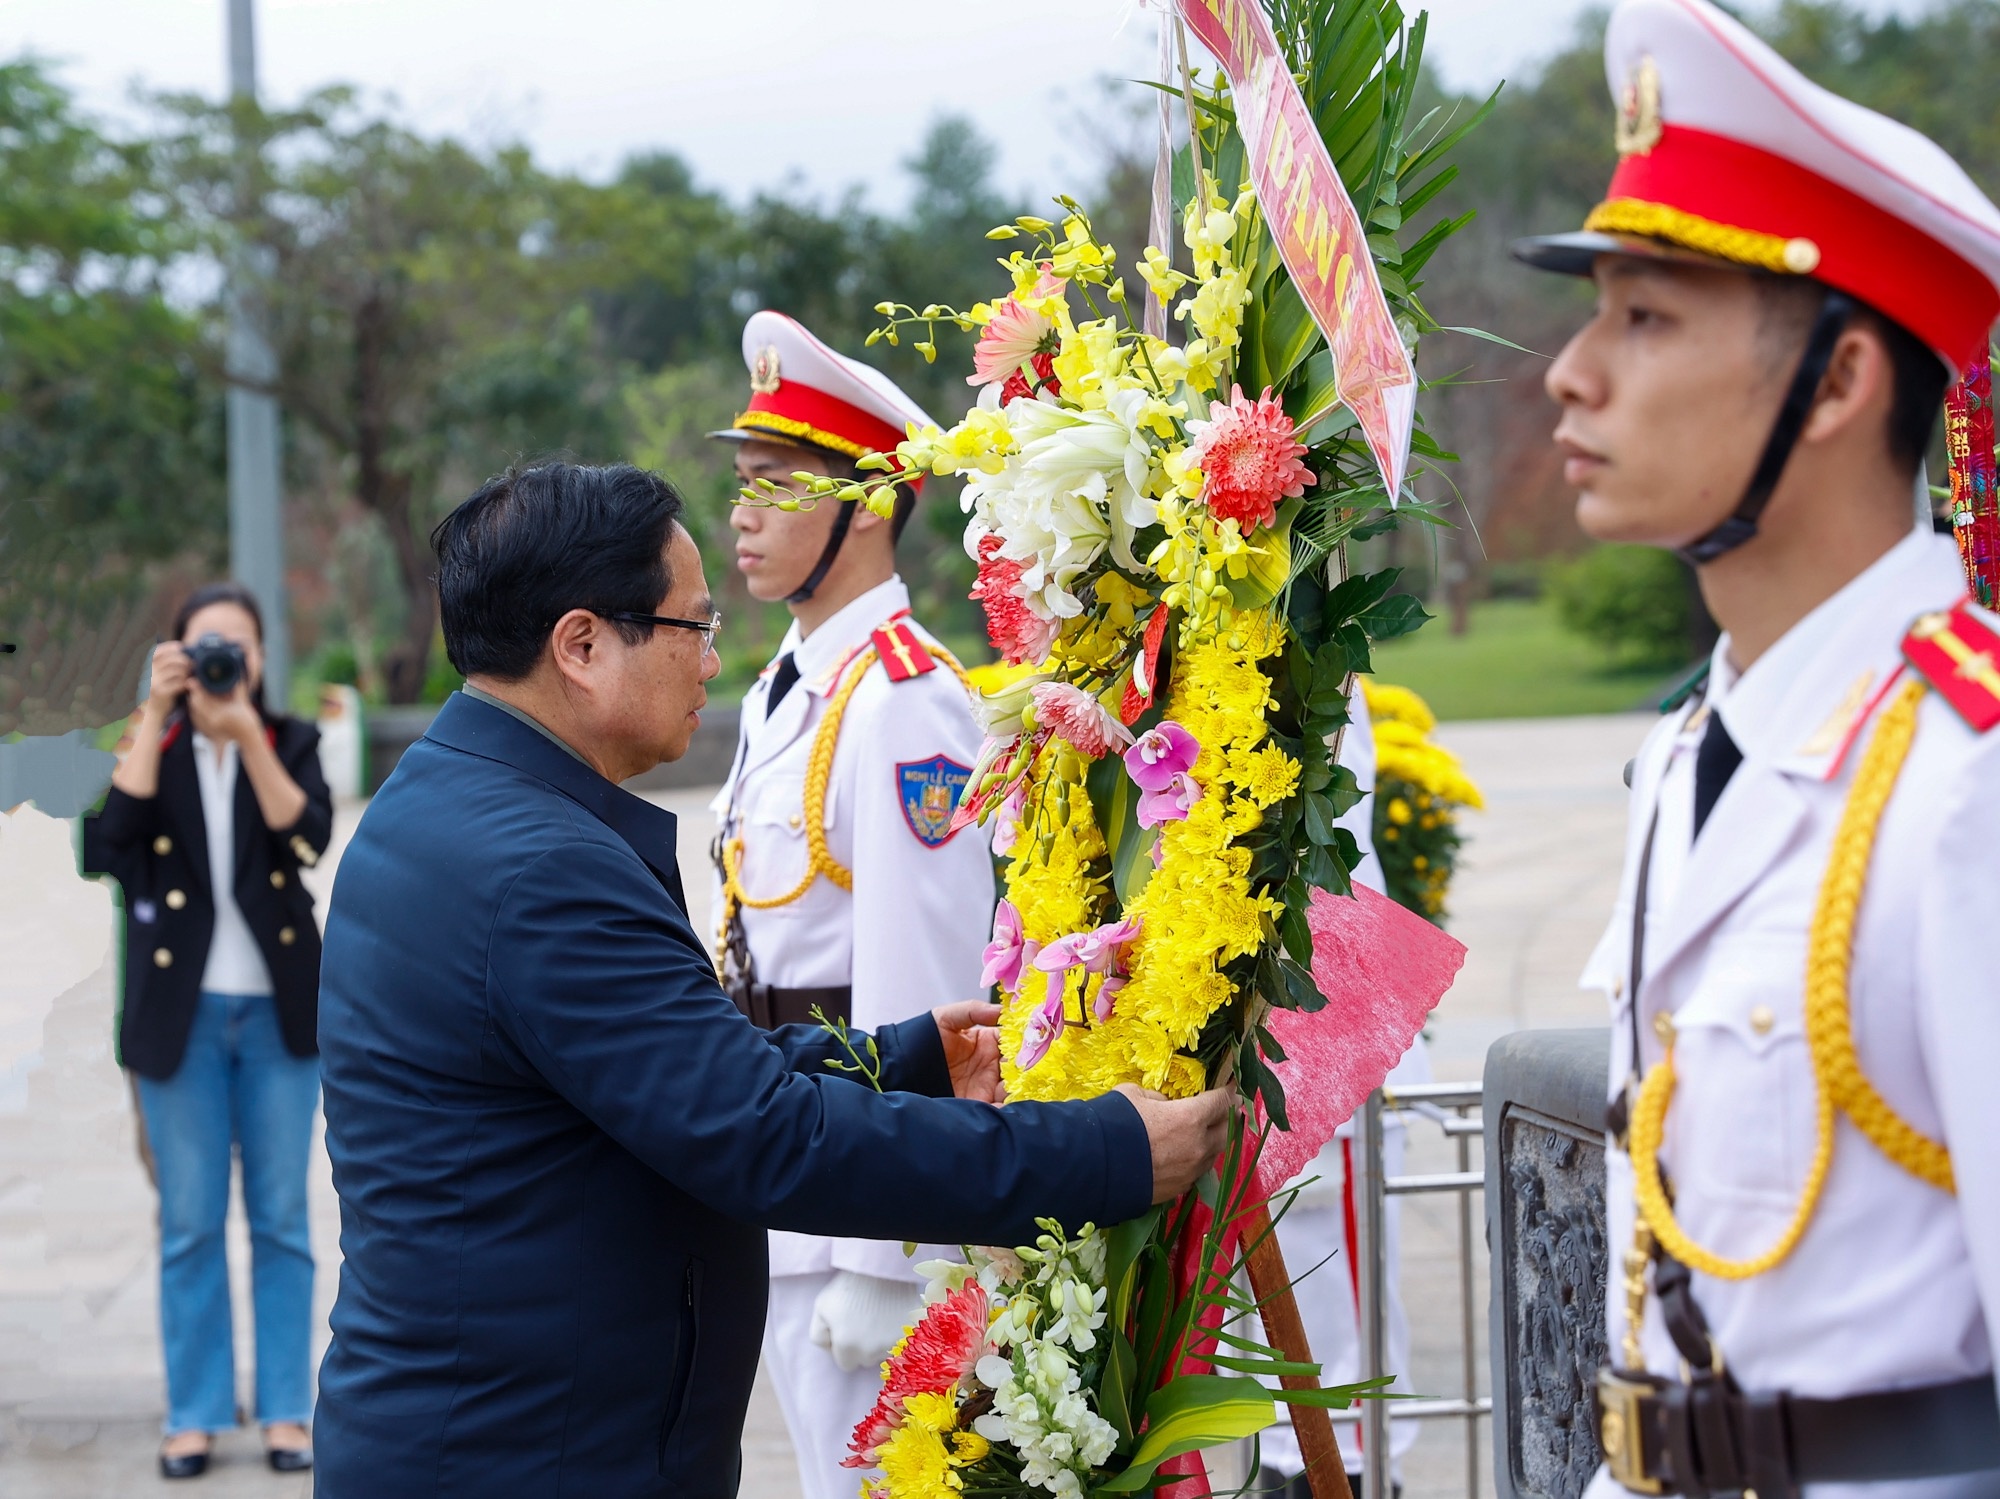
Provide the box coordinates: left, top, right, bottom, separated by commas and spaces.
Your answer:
84, 584, 332, 1479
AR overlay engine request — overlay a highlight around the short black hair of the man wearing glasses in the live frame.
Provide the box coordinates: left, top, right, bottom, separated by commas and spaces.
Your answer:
430, 462, 686, 682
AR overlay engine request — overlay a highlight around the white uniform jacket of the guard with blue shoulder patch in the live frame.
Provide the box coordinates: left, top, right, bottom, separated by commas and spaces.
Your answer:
710, 578, 994, 1281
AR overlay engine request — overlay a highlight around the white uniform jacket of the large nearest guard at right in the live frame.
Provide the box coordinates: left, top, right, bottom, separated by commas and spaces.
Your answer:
1584, 532, 2000, 1431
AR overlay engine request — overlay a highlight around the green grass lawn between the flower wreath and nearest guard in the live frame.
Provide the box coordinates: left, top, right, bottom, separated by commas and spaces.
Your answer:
1374, 600, 1686, 720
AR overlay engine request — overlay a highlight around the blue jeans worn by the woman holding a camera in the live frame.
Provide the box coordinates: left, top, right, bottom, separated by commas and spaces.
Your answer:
138, 993, 320, 1433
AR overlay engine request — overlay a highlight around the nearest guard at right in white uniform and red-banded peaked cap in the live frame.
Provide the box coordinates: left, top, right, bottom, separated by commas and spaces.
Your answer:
1516, 0, 2000, 1499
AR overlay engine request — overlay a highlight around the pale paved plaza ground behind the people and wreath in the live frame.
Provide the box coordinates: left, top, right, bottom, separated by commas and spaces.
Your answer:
0, 718, 1644, 1499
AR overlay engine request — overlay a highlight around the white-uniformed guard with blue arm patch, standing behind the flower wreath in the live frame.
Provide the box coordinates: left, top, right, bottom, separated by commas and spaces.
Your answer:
714, 312, 994, 1499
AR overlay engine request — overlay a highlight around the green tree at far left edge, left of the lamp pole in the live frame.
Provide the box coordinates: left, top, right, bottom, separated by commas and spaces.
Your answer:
0, 60, 226, 734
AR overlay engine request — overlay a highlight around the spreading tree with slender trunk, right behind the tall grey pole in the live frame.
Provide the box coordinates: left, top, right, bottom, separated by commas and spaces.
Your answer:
160, 88, 616, 702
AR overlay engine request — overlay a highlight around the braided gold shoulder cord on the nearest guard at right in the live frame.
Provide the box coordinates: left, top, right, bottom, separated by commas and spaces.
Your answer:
1632, 682, 1956, 1281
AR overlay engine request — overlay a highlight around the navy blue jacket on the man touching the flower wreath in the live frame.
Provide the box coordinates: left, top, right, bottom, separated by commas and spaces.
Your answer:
314, 694, 1152, 1499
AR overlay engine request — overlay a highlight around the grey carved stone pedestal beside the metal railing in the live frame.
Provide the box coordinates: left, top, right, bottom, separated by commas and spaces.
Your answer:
1484, 1029, 1610, 1499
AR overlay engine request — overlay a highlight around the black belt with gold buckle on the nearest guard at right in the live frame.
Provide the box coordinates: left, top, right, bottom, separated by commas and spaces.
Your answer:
1596, 1369, 2000, 1499
